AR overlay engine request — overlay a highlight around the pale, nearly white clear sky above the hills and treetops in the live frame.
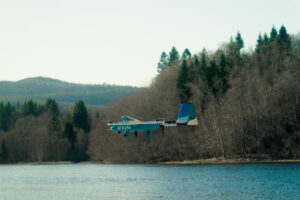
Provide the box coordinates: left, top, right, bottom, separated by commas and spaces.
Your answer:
0, 0, 300, 86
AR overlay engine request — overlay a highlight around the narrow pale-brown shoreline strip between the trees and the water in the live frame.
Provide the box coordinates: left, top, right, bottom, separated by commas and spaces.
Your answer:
0, 158, 300, 166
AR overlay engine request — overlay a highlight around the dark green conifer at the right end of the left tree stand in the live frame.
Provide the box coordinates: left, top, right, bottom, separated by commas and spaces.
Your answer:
73, 100, 90, 133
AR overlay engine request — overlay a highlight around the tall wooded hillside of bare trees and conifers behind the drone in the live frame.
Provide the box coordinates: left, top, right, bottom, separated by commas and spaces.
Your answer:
89, 26, 300, 163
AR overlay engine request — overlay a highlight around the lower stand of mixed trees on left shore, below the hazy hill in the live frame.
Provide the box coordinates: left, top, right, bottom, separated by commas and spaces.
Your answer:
0, 99, 91, 163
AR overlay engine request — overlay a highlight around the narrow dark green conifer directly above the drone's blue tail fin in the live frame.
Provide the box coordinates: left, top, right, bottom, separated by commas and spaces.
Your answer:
177, 60, 191, 102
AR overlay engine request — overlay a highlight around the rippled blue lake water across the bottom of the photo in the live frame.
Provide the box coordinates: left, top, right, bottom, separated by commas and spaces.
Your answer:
0, 163, 300, 200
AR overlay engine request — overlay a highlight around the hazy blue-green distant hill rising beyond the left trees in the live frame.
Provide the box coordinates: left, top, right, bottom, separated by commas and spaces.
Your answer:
0, 77, 139, 106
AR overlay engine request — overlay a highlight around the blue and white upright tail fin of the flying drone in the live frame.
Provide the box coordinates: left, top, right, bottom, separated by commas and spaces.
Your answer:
176, 103, 198, 125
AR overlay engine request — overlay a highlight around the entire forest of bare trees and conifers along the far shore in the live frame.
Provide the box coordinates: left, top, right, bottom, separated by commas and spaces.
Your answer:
0, 26, 300, 163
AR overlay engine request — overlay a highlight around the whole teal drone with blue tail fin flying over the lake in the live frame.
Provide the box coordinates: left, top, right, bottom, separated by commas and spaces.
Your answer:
107, 103, 198, 140
